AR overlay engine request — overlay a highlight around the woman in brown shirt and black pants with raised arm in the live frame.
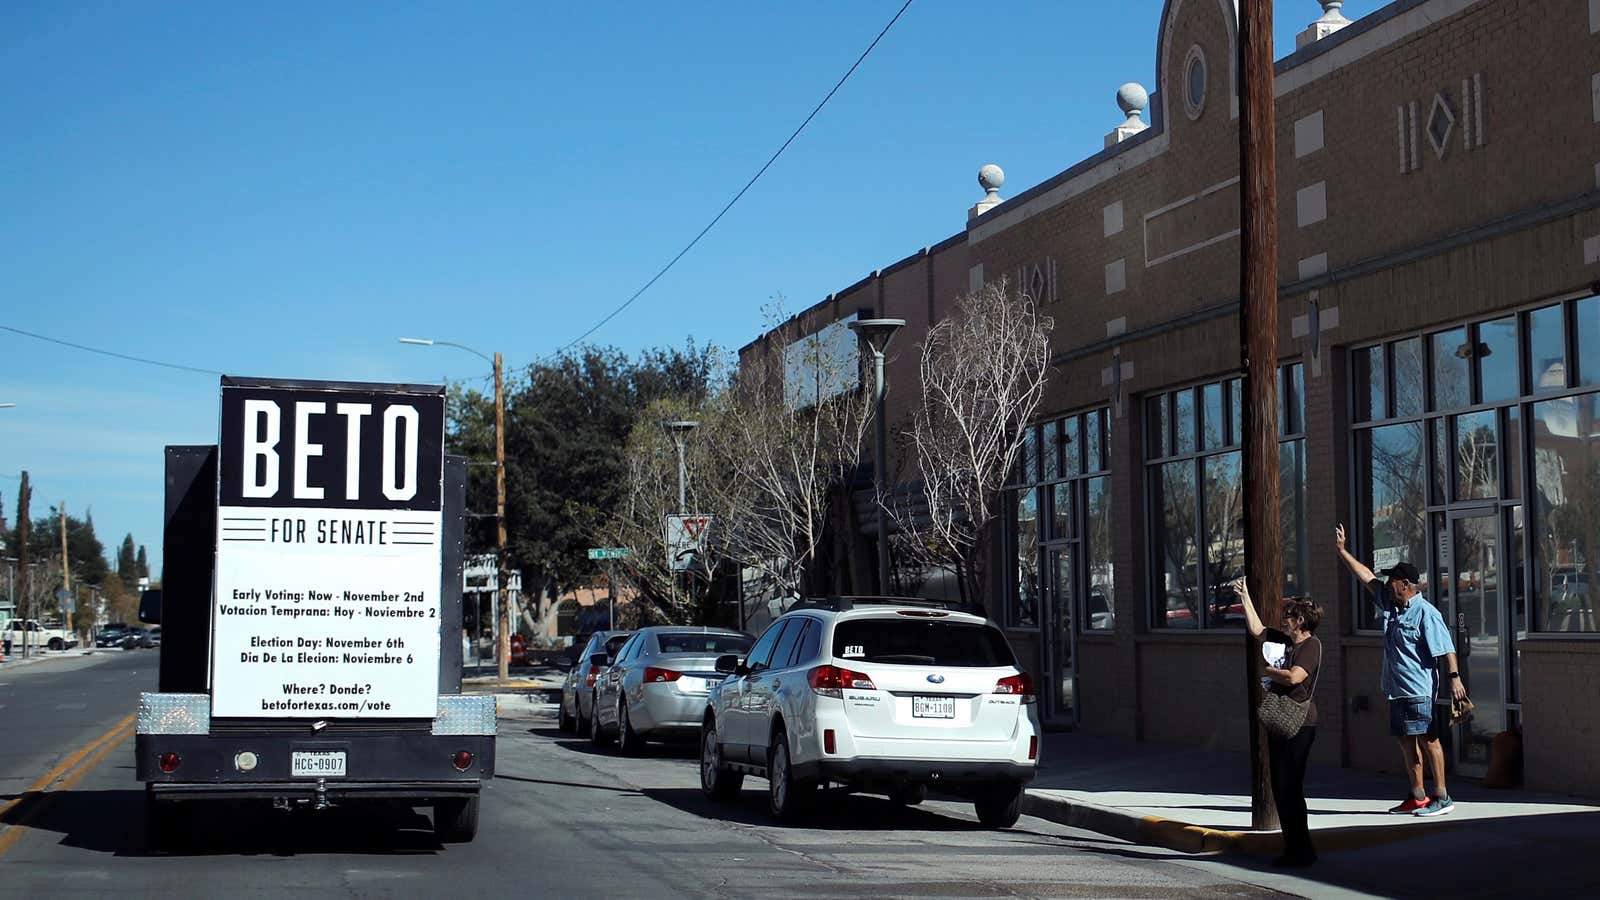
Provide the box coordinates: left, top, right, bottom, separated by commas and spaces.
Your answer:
1234, 578, 1322, 866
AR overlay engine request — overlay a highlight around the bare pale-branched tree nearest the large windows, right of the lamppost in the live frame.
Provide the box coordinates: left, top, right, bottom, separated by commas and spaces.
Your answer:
896, 279, 1054, 601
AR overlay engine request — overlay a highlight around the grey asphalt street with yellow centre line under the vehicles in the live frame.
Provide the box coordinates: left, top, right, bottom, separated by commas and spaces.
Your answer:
0, 650, 1299, 900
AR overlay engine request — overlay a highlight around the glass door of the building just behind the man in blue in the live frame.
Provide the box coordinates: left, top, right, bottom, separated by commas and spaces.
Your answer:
1459, 509, 1510, 775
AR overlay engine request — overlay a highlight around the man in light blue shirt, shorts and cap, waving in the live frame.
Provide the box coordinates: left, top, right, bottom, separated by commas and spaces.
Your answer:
1333, 525, 1467, 817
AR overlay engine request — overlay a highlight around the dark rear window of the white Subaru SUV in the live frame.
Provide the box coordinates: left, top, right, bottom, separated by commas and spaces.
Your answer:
834, 618, 1016, 668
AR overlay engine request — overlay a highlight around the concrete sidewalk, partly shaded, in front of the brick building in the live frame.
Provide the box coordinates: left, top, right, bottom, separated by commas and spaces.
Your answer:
1026, 723, 1600, 855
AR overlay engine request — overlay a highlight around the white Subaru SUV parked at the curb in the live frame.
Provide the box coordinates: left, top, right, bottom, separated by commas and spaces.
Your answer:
701, 597, 1040, 828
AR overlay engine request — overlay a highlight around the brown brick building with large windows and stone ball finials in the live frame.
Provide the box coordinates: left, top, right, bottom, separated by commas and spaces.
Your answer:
742, 0, 1600, 794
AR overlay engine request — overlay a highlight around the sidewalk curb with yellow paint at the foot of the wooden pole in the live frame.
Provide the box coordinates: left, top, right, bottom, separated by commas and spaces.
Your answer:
1022, 791, 1462, 857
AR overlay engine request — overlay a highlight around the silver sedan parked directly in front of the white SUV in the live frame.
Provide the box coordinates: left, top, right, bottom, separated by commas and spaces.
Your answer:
589, 626, 755, 753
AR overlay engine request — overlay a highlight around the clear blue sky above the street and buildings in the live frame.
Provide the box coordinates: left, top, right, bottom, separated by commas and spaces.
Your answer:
0, 0, 1381, 565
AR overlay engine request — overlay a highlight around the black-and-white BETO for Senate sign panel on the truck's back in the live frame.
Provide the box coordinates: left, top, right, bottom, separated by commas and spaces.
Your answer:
211, 378, 445, 719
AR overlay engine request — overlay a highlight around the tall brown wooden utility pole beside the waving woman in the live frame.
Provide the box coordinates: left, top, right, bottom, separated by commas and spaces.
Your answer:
1238, 0, 1283, 830
